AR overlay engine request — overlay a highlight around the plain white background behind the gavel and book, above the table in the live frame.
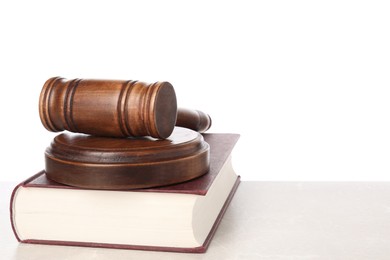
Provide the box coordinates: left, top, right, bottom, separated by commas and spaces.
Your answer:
0, 0, 390, 181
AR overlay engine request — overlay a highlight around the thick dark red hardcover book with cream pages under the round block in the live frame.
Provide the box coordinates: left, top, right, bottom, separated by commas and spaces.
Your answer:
10, 133, 240, 253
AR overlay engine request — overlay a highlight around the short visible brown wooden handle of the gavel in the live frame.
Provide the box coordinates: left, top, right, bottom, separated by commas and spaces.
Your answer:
176, 108, 211, 133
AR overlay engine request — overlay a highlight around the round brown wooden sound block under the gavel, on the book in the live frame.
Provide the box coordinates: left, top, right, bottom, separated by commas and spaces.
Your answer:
45, 127, 210, 190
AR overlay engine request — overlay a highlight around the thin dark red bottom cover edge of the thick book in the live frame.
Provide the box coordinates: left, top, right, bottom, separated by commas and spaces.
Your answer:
17, 175, 241, 253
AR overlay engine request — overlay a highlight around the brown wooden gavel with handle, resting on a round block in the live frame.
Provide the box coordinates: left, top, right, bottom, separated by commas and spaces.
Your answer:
39, 77, 211, 139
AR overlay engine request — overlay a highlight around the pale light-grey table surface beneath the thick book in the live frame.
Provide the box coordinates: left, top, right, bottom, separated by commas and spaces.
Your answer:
0, 182, 390, 260
